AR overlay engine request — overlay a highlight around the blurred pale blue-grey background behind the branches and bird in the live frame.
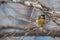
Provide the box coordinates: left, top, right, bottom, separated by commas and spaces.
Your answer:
0, 0, 60, 40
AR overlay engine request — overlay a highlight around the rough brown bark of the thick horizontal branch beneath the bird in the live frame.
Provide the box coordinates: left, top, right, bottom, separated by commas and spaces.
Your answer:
0, 27, 60, 38
